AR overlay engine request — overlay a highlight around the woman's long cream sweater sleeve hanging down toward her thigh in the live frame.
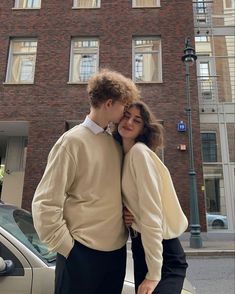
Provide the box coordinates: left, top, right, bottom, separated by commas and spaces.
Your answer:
132, 149, 163, 281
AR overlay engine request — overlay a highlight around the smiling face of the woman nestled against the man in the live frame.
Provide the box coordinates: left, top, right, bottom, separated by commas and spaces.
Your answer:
118, 106, 144, 140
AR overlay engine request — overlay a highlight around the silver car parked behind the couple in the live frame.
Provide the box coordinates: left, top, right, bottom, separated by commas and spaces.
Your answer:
0, 204, 195, 294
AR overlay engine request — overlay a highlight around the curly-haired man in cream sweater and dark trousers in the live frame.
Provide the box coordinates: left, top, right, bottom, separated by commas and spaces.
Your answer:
32, 70, 139, 294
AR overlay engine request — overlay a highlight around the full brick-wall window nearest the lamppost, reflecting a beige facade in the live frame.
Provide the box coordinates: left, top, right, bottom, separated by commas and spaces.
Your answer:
133, 38, 162, 83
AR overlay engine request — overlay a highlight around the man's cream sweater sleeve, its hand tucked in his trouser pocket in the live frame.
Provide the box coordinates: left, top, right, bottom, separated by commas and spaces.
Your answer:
32, 143, 76, 257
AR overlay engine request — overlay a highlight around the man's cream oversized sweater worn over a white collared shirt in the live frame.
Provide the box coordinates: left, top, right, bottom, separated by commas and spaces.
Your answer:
32, 125, 127, 257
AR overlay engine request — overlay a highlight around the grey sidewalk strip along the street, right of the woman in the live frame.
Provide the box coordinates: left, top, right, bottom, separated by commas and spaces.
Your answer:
180, 232, 235, 257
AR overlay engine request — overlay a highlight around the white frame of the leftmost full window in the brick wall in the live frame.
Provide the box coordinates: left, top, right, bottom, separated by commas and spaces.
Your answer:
5, 38, 38, 84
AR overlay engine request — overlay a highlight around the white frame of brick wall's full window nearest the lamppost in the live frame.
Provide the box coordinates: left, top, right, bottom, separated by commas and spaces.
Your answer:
132, 36, 163, 84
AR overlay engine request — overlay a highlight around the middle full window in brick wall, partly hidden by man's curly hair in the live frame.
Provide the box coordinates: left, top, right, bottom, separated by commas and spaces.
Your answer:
69, 38, 99, 83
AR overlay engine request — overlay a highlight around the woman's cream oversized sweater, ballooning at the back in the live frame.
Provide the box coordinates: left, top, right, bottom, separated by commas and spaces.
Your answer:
122, 143, 188, 281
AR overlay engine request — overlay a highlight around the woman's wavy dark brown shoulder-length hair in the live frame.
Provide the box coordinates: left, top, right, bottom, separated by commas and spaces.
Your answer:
113, 101, 164, 151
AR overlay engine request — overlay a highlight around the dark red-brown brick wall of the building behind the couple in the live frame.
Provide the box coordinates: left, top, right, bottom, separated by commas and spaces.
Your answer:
0, 0, 206, 230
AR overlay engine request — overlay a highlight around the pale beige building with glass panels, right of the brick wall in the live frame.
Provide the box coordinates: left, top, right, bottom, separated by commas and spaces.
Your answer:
193, 0, 235, 232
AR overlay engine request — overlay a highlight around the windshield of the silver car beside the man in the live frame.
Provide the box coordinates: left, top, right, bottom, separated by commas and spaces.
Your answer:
0, 207, 56, 263
